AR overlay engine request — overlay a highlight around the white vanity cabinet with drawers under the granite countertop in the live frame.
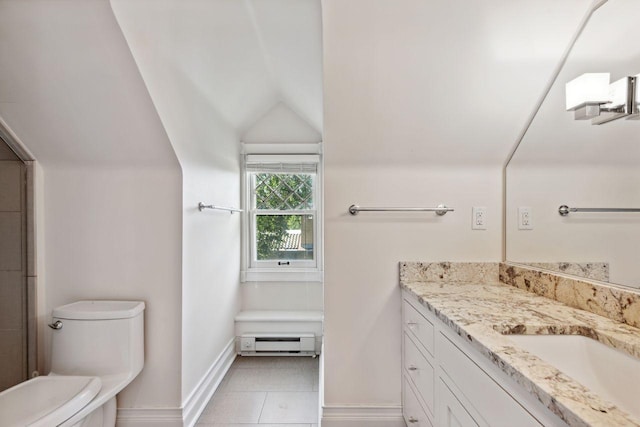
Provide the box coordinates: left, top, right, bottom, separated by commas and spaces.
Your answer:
402, 291, 566, 427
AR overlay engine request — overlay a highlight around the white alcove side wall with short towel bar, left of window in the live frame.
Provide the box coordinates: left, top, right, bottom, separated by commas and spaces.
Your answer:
112, 0, 240, 405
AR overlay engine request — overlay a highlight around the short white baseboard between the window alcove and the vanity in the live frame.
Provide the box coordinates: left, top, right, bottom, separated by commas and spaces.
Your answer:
322, 406, 406, 427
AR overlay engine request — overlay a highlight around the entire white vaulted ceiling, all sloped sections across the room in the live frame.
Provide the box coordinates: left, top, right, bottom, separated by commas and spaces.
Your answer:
0, 0, 624, 169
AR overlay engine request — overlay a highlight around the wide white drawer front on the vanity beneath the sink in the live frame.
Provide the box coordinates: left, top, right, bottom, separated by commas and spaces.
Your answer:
437, 333, 542, 427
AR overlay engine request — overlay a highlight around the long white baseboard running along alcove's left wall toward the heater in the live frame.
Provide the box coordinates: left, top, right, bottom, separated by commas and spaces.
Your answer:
182, 337, 236, 427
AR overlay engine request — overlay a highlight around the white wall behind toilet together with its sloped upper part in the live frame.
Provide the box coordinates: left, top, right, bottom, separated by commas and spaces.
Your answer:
0, 0, 182, 408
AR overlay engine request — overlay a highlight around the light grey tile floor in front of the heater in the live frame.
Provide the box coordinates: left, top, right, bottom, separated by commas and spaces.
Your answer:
196, 356, 319, 427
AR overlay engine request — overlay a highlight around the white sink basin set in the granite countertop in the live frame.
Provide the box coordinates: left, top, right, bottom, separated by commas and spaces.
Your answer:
505, 335, 640, 418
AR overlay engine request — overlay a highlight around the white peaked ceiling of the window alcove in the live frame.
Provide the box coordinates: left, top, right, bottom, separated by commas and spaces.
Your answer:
111, 0, 322, 137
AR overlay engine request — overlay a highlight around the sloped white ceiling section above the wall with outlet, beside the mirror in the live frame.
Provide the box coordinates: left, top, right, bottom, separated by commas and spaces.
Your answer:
322, 0, 592, 168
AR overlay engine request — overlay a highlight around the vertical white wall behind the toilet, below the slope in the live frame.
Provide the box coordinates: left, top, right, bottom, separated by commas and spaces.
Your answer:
43, 166, 182, 408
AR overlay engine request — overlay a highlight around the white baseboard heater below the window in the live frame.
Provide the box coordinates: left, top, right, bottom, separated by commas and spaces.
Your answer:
240, 333, 316, 356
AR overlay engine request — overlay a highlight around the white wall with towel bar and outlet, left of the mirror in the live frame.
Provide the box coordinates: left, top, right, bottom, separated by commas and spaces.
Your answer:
324, 165, 501, 406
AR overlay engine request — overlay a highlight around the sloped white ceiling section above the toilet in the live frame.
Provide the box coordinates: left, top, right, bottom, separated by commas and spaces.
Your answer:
0, 0, 178, 170
